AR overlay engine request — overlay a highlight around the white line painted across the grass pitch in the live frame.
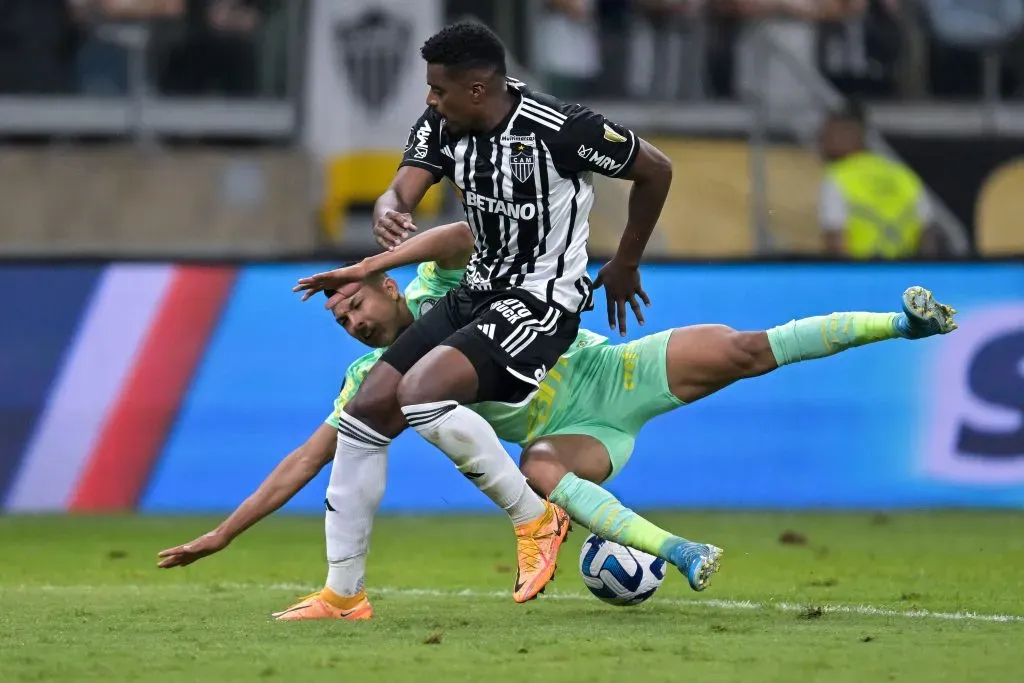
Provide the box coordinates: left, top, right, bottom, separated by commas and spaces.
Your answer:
0, 582, 1024, 624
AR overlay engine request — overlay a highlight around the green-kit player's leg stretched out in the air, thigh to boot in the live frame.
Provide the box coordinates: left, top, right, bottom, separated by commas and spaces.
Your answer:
668, 287, 956, 403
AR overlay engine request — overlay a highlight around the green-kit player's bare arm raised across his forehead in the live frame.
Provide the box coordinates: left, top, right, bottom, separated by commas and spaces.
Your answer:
292, 221, 474, 308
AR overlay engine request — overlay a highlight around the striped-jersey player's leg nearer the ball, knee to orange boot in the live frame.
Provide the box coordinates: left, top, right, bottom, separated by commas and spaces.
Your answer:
398, 346, 569, 602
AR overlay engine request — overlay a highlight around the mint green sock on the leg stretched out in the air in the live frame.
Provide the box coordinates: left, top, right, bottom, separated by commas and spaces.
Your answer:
768, 313, 903, 367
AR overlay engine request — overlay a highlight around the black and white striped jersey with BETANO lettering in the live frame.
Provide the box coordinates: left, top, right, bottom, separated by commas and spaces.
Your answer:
401, 79, 639, 312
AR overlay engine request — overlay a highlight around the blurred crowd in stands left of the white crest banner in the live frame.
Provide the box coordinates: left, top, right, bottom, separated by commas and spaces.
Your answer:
0, 0, 287, 97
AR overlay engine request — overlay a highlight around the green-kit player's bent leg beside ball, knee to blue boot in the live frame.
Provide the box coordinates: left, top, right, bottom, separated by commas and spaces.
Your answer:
519, 434, 722, 591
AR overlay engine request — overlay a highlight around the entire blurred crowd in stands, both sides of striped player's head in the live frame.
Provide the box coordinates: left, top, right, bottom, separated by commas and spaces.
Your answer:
0, 0, 1024, 100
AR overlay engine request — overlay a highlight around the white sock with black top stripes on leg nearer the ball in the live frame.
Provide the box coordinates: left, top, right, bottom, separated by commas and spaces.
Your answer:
401, 400, 545, 524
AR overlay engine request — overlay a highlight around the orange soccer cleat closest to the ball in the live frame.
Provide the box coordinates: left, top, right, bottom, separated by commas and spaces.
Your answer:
512, 502, 569, 602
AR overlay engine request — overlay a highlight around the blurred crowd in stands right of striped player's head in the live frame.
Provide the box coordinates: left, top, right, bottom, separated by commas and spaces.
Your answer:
532, 0, 1024, 99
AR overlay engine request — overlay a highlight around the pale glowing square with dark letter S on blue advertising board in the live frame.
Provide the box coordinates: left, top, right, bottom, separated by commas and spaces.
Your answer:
924, 304, 1024, 485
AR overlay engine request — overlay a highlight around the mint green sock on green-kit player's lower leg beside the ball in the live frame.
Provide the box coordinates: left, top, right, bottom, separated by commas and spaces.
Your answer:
548, 472, 686, 561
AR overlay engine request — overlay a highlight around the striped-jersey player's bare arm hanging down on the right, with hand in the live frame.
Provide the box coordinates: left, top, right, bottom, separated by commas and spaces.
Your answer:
594, 137, 672, 335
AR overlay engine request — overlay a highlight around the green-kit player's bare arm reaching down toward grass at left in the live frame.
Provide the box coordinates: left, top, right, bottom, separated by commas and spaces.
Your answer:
158, 424, 338, 569
